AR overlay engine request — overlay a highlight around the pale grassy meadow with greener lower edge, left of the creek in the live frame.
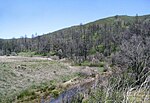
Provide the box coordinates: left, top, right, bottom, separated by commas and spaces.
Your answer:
0, 57, 82, 103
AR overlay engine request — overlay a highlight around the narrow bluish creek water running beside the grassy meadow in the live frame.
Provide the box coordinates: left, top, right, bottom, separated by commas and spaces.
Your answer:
41, 77, 95, 103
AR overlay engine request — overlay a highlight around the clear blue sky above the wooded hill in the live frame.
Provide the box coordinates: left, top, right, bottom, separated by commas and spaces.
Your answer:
0, 0, 150, 39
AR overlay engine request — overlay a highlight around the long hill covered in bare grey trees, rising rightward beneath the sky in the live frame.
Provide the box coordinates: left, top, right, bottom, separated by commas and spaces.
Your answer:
0, 15, 150, 60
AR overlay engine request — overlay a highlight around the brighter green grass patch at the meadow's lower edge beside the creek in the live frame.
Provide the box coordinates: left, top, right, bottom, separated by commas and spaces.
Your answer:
17, 80, 56, 102
